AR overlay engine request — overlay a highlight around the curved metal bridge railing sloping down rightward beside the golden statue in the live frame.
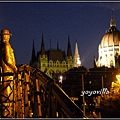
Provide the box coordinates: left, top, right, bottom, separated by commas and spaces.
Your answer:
0, 64, 86, 118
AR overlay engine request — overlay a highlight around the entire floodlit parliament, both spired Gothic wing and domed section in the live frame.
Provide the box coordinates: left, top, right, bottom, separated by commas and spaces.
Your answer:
30, 11, 120, 78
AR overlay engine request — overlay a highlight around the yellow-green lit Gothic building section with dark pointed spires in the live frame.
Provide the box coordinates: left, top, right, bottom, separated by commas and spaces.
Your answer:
30, 34, 81, 78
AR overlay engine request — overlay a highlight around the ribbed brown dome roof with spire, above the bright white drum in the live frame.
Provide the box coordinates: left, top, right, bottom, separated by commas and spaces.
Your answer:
100, 10, 120, 47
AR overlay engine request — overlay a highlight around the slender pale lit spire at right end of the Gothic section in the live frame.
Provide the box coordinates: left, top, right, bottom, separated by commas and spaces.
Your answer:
73, 42, 81, 67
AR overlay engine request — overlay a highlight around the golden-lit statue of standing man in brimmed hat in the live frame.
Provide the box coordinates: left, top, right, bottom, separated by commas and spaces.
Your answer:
0, 29, 18, 118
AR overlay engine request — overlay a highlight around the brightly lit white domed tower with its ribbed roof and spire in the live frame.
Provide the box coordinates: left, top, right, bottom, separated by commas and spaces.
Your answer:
96, 11, 120, 68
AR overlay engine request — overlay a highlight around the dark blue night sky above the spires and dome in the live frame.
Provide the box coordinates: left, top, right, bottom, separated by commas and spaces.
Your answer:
0, 2, 120, 68
